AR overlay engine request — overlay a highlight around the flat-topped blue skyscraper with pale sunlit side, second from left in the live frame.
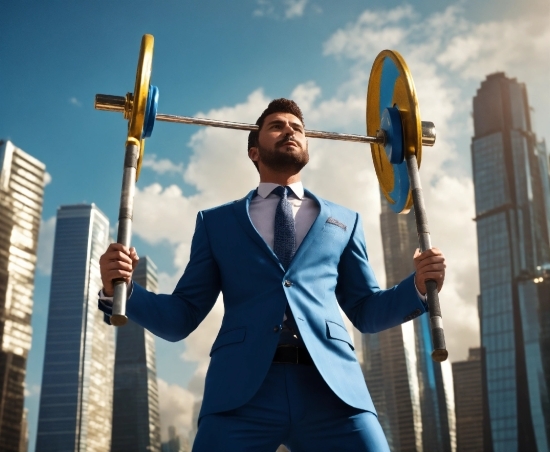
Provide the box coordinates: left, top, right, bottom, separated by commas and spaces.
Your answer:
36, 204, 114, 452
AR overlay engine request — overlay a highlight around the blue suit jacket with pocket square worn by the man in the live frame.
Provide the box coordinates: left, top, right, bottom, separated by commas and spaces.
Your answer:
127, 190, 425, 416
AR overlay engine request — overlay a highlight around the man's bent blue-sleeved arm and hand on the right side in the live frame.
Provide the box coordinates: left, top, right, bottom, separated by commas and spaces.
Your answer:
336, 215, 444, 333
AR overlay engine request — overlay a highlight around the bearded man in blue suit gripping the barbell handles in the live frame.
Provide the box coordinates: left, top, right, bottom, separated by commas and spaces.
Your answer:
100, 99, 445, 452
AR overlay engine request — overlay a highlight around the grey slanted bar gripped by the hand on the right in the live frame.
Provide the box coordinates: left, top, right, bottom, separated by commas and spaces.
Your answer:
406, 154, 449, 362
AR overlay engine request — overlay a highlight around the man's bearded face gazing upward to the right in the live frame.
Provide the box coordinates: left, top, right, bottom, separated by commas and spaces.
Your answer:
249, 113, 309, 174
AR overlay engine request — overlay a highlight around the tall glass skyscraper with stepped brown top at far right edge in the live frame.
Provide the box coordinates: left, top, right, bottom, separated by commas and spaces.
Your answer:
471, 73, 550, 452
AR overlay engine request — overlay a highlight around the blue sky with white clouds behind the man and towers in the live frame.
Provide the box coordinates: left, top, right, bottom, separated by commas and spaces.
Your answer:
0, 0, 550, 451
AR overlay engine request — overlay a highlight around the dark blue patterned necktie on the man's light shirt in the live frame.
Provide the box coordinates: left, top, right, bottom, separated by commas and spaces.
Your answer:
272, 186, 296, 270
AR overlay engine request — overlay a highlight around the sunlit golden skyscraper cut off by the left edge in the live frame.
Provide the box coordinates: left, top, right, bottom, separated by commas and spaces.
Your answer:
0, 141, 46, 452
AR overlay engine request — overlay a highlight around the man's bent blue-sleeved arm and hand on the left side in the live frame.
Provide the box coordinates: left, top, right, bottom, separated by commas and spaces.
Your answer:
100, 213, 221, 342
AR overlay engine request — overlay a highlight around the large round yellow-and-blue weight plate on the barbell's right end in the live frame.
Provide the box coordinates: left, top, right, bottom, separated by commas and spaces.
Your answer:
366, 50, 422, 213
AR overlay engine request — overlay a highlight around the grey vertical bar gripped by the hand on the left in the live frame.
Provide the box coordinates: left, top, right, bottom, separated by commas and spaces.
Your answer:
111, 140, 139, 326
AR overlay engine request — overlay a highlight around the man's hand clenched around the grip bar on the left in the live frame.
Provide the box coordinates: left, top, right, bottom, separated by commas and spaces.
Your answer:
99, 243, 139, 297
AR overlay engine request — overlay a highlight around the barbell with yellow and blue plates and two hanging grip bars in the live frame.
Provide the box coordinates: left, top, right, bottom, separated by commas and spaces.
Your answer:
95, 35, 448, 362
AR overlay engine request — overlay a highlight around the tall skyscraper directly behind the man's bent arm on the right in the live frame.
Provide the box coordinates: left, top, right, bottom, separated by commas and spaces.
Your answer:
363, 193, 455, 452
